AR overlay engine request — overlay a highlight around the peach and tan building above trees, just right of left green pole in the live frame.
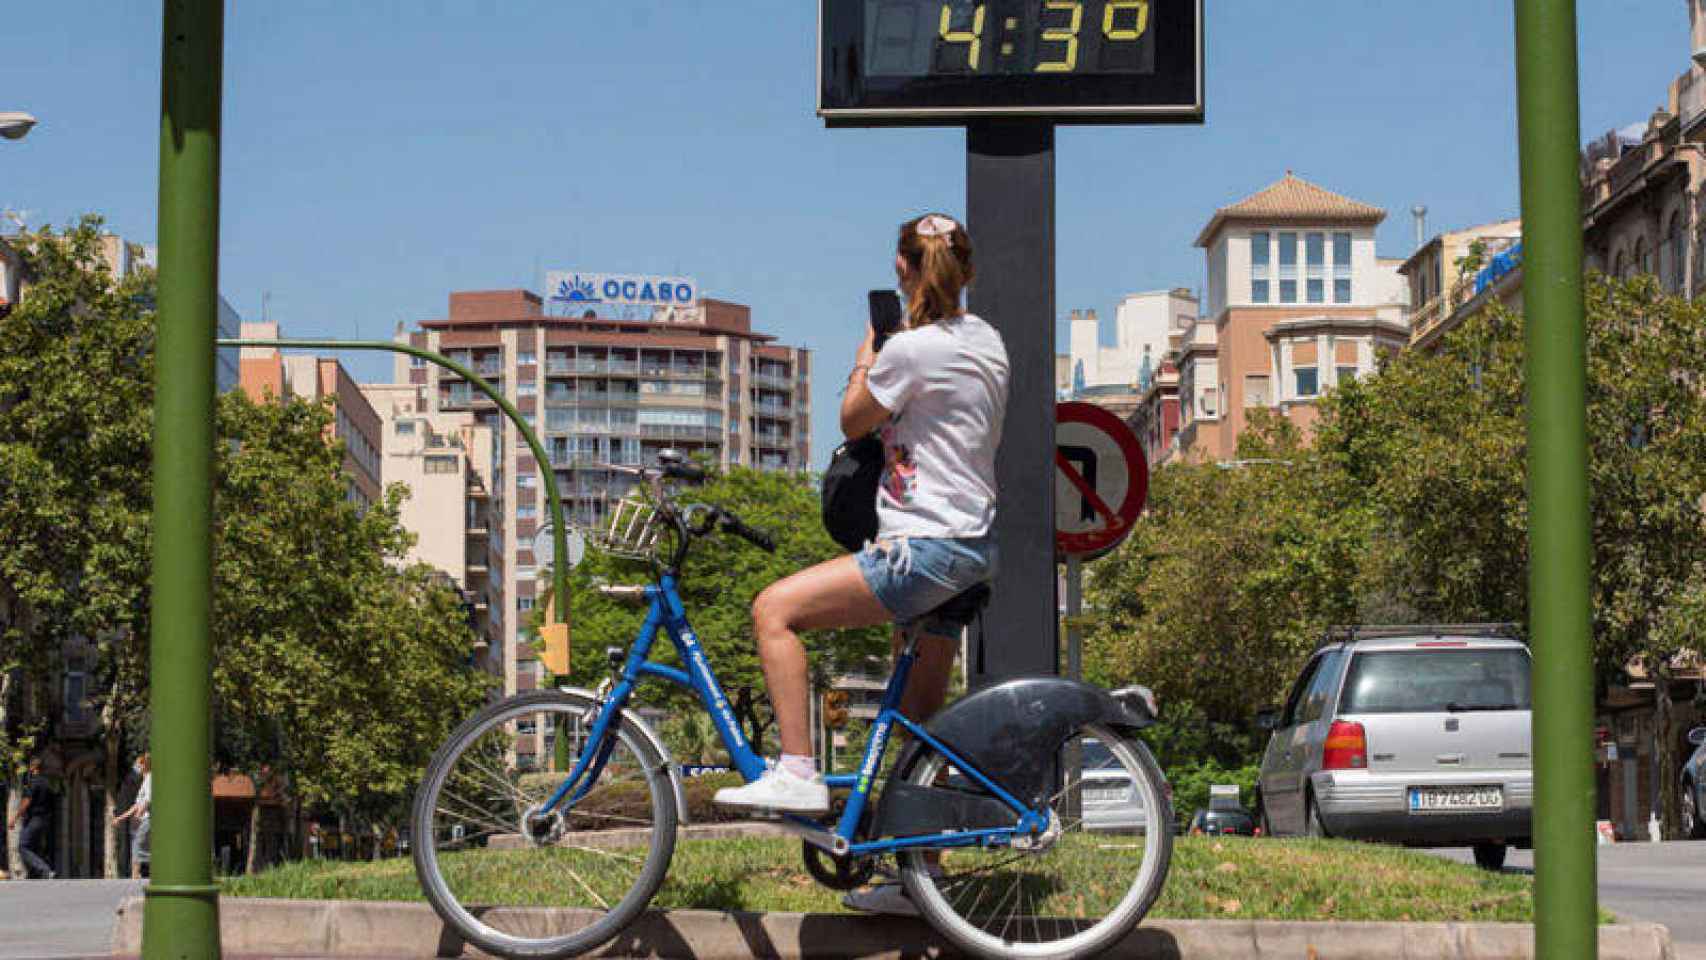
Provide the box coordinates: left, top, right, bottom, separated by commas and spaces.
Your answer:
237, 322, 382, 505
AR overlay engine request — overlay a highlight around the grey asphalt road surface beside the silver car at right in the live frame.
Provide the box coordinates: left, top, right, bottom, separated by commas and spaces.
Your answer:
1430, 841, 1706, 960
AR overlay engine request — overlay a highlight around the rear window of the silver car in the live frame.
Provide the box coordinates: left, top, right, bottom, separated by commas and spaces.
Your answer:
1339, 646, 1530, 713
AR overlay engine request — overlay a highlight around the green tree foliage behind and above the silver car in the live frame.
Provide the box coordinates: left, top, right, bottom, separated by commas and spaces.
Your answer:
1085, 278, 1706, 787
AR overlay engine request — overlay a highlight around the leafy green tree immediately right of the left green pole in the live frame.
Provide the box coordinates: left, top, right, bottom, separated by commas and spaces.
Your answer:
213, 392, 488, 870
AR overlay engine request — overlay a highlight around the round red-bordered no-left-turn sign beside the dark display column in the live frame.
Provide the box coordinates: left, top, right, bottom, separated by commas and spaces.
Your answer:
1054, 402, 1150, 556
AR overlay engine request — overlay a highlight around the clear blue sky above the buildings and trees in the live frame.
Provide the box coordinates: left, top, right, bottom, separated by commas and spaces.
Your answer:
0, 0, 1689, 464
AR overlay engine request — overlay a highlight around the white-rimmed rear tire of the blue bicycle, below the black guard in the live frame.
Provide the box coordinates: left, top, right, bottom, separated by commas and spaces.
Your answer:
899, 725, 1174, 960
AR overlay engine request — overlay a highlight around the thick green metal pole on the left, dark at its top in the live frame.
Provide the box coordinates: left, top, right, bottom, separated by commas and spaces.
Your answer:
142, 0, 225, 960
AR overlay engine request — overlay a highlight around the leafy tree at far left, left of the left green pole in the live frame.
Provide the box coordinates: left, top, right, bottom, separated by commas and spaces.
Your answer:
0, 217, 154, 870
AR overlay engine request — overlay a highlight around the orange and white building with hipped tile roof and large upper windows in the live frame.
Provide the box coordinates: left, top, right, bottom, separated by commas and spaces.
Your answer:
1179, 171, 1409, 460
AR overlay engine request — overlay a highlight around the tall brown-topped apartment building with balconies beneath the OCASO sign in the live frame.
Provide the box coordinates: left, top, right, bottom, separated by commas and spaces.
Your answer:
394, 290, 810, 766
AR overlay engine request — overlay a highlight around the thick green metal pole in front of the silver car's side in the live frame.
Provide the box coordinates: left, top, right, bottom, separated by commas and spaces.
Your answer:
1517, 0, 1599, 960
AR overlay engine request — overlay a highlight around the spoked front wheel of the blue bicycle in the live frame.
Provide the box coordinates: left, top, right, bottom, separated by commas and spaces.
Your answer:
413, 691, 677, 958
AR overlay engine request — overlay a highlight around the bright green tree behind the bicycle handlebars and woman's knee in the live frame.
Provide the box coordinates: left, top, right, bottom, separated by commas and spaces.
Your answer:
536, 467, 889, 750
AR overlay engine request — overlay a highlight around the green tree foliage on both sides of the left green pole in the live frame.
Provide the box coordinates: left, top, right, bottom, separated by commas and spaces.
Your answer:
0, 218, 488, 835
